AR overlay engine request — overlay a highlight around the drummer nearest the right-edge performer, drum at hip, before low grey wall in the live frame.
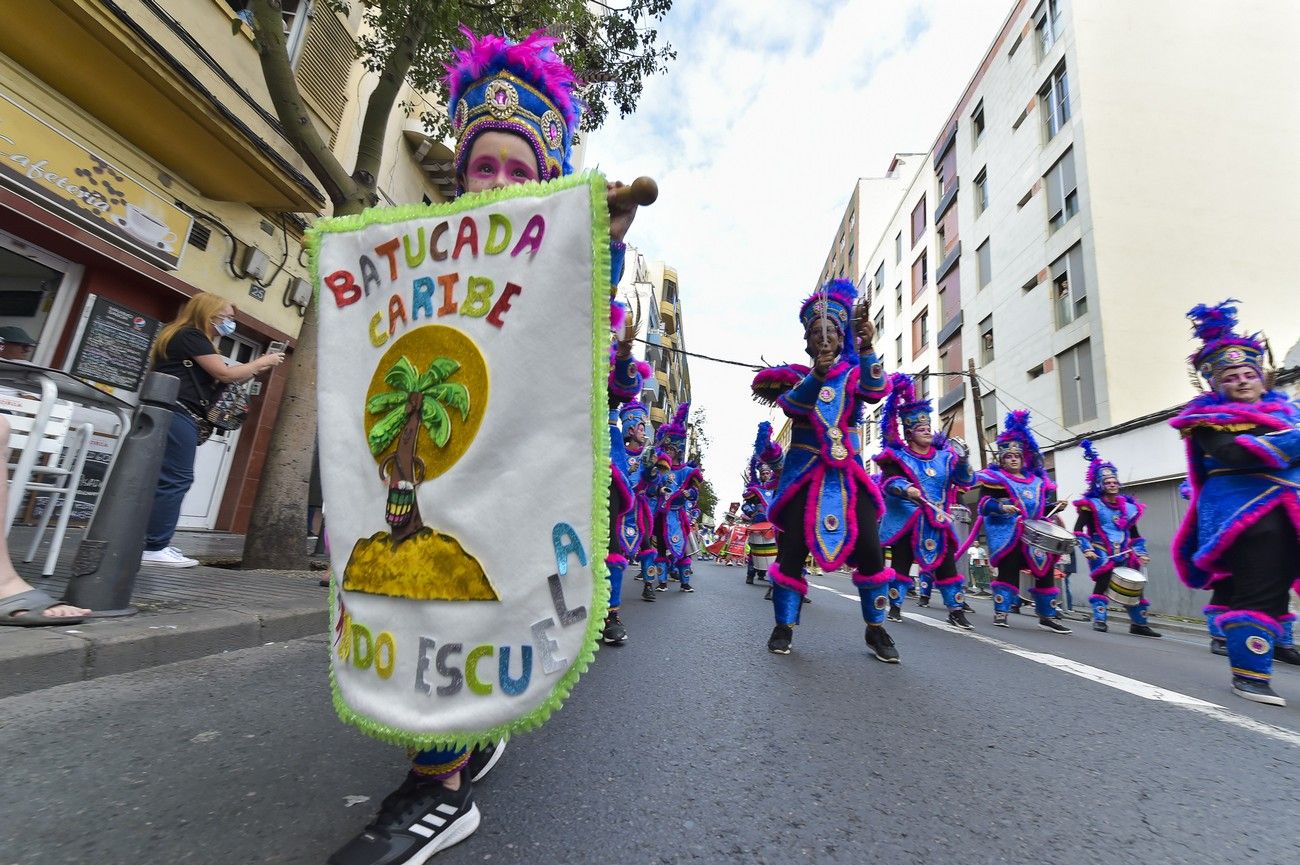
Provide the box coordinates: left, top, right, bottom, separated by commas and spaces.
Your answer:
1074, 438, 1161, 637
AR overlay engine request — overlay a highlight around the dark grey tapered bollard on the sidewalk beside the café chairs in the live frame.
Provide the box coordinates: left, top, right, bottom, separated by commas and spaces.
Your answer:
64, 372, 181, 617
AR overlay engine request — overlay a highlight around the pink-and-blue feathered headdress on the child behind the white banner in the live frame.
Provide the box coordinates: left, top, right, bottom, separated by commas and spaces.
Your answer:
443, 27, 582, 191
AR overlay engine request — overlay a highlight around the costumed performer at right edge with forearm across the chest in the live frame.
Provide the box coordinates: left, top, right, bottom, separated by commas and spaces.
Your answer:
1170, 298, 1300, 706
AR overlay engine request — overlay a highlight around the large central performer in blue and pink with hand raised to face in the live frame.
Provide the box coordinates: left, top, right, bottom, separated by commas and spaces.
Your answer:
753, 280, 898, 663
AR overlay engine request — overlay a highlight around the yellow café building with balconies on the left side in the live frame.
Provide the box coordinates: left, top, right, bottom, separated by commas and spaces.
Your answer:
0, 0, 452, 532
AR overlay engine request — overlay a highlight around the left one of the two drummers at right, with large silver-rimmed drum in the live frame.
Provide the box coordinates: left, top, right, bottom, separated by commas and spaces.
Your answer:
963, 410, 1075, 635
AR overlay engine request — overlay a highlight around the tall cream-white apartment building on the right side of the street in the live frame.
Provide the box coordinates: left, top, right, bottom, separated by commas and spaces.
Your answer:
827, 0, 1300, 615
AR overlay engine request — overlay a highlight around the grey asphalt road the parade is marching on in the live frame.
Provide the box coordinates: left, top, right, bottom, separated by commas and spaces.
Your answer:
0, 565, 1300, 865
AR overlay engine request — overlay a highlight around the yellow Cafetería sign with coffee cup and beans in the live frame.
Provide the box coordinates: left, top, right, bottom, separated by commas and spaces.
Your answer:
0, 92, 191, 269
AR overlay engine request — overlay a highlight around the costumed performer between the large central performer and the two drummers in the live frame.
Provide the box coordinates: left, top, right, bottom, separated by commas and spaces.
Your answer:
874, 372, 975, 631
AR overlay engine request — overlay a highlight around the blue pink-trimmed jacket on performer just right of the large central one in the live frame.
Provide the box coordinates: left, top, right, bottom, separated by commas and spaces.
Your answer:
874, 445, 975, 574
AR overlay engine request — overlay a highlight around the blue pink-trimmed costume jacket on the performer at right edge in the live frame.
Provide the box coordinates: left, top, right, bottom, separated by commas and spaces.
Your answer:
1169, 390, 1300, 589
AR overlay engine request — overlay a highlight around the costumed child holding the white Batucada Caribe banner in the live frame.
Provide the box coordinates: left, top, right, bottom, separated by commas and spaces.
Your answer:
329, 29, 641, 865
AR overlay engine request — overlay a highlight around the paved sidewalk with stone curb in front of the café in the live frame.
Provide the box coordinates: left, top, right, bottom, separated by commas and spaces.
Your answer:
0, 528, 329, 699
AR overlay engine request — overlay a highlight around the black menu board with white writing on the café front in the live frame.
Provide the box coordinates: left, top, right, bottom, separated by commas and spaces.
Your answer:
69, 297, 160, 390
